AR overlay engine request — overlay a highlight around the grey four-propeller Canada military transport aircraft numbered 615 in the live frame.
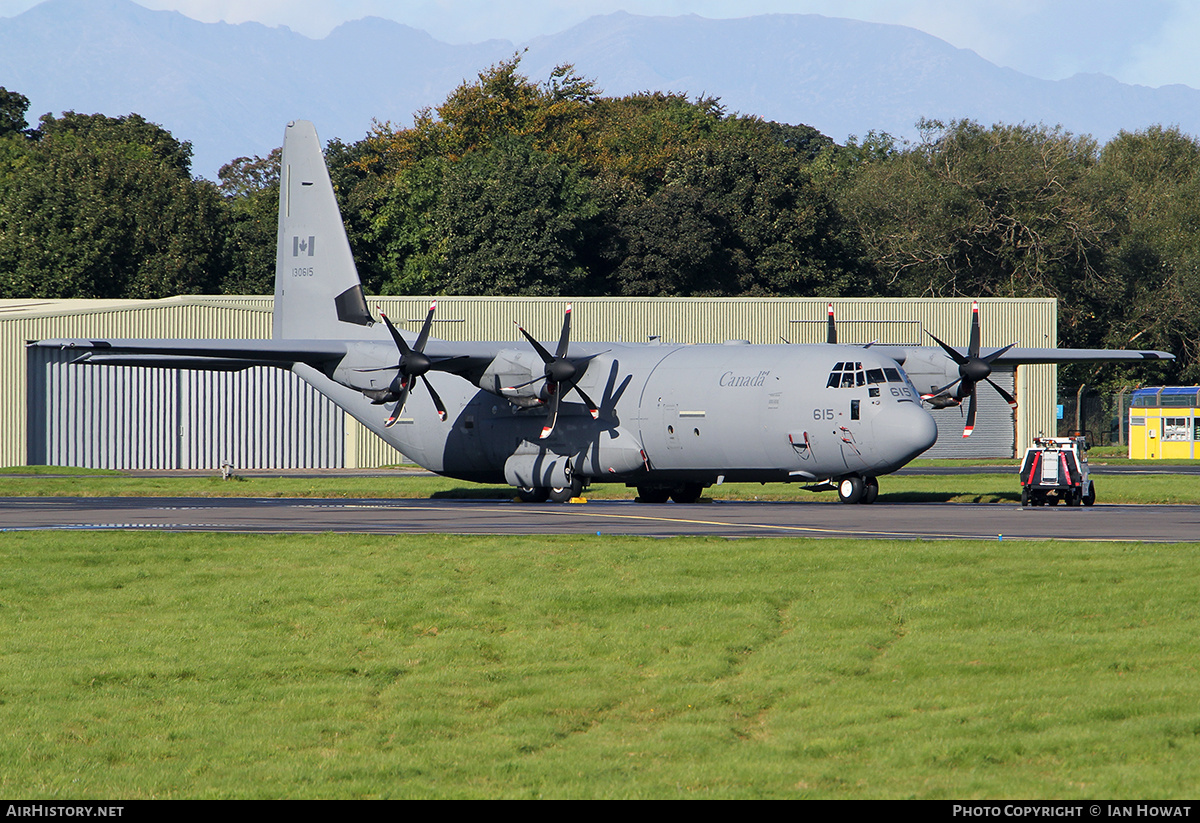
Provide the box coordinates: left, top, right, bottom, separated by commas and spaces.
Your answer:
34, 121, 1171, 503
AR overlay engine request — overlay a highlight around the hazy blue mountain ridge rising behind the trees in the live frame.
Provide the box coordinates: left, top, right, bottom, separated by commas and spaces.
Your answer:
0, 0, 1200, 179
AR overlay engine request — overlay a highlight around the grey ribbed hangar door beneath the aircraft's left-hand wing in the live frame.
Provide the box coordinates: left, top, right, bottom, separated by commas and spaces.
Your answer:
26, 348, 346, 470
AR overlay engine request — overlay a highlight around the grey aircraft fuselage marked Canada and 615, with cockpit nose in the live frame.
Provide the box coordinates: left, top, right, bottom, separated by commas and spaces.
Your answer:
300, 343, 937, 494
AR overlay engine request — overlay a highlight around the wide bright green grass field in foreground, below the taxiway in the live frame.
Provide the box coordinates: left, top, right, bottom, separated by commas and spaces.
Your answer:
0, 533, 1200, 799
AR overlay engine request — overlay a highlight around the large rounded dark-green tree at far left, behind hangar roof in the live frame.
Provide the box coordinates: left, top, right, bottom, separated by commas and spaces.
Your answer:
0, 112, 220, 298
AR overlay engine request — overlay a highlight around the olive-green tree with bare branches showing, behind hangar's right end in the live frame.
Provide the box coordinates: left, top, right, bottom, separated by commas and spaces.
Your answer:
839, 121, 1118, 346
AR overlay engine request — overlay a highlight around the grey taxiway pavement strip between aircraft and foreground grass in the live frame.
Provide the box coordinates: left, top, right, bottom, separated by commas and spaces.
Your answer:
0, 497, 1200, 542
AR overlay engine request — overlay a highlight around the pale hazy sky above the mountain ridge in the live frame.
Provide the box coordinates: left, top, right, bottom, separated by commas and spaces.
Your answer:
7, 0, 1200, 89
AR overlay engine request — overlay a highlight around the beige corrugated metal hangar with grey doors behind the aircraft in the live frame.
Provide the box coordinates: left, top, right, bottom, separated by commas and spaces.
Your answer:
7, 296, 1057, 469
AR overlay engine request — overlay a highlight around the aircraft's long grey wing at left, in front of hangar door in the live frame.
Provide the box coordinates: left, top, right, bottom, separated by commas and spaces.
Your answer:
29, 340, 347, 370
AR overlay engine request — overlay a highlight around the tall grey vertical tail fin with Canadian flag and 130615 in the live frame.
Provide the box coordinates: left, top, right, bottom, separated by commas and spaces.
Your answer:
272, 120, 372, 340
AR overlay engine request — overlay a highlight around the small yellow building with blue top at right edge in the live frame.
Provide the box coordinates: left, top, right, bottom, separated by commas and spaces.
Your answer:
1129, 386, 1200, 459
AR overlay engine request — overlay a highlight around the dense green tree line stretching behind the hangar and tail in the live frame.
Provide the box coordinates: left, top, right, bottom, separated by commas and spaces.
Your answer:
0, 59, 1200, 382
